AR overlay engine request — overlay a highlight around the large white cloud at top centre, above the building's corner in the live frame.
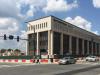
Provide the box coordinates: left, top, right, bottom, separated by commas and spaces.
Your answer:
43, 0, 78, 12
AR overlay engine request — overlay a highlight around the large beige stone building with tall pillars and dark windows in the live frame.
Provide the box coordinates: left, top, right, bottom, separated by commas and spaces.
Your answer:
27, 16, 100, 56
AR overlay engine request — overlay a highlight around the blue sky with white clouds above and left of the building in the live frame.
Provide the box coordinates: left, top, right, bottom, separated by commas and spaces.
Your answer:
0, 0, 100, 51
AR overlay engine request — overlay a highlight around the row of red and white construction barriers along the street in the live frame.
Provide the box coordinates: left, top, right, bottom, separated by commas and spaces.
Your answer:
0, 59, 90, 64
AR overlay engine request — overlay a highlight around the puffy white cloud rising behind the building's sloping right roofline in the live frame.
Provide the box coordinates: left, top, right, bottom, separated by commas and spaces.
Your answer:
65, 16, 98, 34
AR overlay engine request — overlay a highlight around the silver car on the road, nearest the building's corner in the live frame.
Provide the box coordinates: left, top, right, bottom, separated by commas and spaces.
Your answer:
58, 57, 76, 65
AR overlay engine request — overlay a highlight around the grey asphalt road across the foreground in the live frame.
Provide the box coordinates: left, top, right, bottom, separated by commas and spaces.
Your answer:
0, 64, 100, 75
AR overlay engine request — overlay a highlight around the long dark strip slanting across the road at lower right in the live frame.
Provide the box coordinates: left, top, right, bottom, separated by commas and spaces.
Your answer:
55, 65, 100, 75
